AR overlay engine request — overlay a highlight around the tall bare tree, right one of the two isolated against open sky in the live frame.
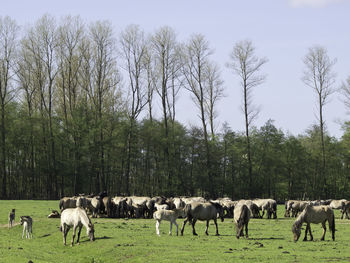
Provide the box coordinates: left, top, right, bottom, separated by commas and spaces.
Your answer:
302, 46, 336, 196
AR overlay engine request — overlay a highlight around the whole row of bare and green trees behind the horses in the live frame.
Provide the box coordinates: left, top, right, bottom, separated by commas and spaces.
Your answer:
0, 15, 350, 199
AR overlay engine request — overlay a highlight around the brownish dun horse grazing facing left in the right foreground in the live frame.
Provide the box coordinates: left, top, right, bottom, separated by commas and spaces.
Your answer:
292, 206, 335, 242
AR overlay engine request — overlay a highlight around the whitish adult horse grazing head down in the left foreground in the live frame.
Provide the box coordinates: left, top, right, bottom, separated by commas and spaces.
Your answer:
60, 207, 95, 246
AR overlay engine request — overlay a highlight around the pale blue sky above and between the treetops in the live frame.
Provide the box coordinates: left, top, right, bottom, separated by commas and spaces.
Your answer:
0, 0, 350, 138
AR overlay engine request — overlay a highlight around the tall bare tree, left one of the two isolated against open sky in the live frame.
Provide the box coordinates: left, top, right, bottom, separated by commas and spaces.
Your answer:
228, 40, 267, 196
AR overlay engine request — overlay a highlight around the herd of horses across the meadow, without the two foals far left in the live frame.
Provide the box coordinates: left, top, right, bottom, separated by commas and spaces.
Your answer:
54, 193, 350, 248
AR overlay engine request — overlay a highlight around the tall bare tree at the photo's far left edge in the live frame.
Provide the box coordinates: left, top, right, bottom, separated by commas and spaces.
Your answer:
0, 17, 19, 198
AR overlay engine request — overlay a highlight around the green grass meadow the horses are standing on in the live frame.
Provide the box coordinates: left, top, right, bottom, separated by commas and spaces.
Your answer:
0, 200, 350, 263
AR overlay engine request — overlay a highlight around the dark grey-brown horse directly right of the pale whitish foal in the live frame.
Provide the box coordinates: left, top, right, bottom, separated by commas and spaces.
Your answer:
181, 202, 224, 236
